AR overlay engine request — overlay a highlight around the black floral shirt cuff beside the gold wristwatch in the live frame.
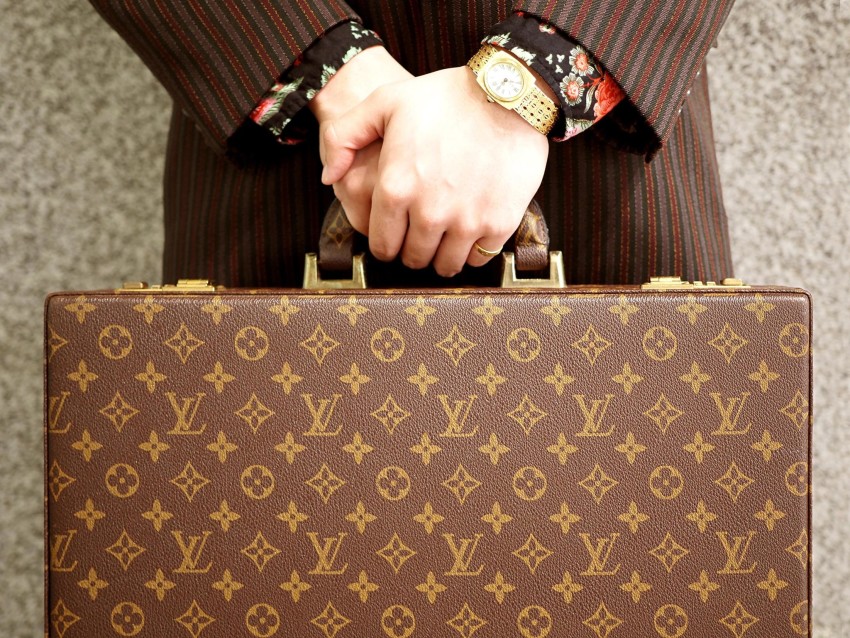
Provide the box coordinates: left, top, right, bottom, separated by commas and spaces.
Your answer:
483, 11, 625, 142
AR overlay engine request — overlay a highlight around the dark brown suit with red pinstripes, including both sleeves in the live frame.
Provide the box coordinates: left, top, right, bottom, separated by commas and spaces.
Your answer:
92, 0, 732, 286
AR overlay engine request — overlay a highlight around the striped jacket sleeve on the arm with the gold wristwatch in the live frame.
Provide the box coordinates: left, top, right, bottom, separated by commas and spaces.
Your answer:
514, 0, 734, 155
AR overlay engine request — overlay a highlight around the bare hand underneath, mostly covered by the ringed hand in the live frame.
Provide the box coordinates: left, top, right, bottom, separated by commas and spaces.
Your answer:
309, 46, 413, 234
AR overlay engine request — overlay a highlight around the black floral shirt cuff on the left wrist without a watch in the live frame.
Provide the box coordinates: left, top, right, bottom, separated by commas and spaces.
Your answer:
249, 21, 383, 144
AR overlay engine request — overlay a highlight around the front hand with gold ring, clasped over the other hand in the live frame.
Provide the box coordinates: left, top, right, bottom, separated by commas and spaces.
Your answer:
321, 66, 549, 276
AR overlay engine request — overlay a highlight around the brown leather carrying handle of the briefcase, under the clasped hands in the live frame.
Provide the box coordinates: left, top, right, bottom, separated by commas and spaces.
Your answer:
319, 199, 549, 272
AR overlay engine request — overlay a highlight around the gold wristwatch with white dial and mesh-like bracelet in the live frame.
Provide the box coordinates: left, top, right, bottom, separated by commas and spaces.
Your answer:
466, 44, 558, 135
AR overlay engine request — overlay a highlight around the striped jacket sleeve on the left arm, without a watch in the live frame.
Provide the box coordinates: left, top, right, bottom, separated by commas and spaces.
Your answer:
90, 0, 359, 152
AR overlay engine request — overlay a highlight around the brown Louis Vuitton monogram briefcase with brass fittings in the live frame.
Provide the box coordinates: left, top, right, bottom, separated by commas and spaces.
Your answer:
45, 209, 812, 638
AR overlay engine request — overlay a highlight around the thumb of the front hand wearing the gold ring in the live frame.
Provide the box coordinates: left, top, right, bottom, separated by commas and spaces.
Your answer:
322, 96, 387, 186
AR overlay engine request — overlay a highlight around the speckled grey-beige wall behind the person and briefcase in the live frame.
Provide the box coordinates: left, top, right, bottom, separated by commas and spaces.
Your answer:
0, 0, 850, 638
